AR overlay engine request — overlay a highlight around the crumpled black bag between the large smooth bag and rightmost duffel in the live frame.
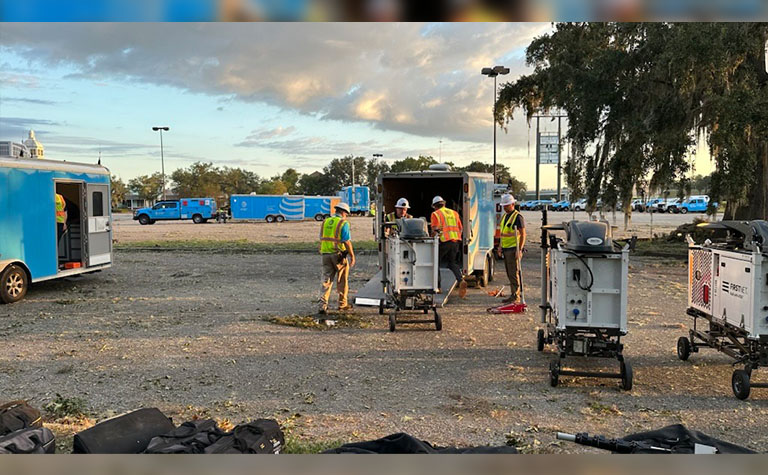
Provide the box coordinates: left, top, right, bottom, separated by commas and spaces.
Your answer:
145, 419, 229, 454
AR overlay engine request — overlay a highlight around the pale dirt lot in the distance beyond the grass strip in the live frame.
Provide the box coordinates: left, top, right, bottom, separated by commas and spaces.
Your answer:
114, 211, 706, 243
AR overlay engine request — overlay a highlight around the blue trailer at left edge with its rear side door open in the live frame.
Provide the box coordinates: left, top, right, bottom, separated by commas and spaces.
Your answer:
0, 157, 112, 303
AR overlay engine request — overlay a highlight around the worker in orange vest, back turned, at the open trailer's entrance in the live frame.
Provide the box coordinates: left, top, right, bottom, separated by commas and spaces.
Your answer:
430, 196, 467, 298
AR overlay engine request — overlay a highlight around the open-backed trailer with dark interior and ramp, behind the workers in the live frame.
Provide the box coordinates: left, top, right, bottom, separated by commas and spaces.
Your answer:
355, 165, 496, 306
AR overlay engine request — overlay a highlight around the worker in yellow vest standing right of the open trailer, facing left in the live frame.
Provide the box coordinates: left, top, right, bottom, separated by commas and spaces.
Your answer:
497, 193, 525, 303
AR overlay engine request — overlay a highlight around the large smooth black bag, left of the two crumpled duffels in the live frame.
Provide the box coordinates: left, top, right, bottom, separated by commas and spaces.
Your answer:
72, 407, 175, 454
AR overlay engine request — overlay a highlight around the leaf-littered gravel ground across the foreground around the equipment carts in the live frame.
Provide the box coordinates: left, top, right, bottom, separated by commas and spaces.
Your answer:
0, 249, 768, 452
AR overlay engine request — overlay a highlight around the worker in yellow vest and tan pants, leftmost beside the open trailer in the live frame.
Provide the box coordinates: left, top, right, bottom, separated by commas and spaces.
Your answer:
318, 202, 355, 315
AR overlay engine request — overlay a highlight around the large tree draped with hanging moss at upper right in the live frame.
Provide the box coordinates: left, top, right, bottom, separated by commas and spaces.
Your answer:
496, 23, 768, 225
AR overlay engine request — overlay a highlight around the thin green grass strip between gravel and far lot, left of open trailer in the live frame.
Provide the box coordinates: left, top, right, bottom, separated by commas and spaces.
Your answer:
115, 239, 378, 253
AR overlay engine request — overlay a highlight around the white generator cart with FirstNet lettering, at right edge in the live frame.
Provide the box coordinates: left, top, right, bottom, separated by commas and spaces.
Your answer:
677, 220, 768, 399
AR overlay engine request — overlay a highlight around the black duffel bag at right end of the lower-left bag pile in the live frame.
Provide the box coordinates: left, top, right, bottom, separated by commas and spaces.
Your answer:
205, 419, 285, 454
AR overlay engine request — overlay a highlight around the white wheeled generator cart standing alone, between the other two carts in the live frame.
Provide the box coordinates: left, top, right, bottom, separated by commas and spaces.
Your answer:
536, 216, 635, 390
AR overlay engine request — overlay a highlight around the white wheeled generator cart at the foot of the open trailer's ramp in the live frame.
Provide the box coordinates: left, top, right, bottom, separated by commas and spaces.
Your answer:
379, 218, 443, 332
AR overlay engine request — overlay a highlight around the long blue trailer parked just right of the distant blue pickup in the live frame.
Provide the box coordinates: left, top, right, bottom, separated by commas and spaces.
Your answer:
229, 195, 304, 223
